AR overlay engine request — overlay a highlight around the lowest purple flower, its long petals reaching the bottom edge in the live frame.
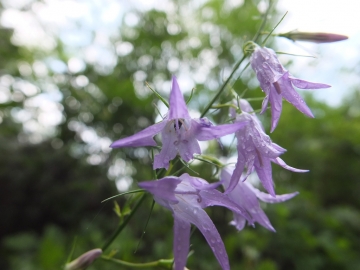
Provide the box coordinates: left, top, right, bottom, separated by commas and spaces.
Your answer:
139, 174, 252, 270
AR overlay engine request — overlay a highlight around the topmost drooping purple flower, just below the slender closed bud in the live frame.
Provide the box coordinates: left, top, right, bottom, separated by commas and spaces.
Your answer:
250, 46, 330, 132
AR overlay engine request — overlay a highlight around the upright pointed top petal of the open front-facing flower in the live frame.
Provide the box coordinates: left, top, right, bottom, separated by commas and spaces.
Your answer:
169, 76, 190, 120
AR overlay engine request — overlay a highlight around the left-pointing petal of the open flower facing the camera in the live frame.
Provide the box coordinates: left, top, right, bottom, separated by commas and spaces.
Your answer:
110, 121, 166, 148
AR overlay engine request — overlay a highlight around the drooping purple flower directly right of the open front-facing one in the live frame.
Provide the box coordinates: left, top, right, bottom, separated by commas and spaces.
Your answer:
225, 99, 308, 196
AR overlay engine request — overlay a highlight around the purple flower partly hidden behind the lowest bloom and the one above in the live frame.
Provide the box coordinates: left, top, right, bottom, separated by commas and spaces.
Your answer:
220, 168, 299, 232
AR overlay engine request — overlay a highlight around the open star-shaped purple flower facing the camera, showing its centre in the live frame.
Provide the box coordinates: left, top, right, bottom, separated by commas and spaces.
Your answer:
110, 76, 246, 169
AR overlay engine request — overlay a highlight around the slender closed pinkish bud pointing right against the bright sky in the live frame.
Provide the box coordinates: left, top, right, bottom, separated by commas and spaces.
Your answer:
278, 31, 348, 43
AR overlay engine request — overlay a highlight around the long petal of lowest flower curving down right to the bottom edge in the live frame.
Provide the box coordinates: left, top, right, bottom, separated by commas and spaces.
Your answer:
173, 201, 230, 270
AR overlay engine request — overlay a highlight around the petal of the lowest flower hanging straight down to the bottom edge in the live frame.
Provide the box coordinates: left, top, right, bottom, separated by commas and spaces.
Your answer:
173, 213, 191, 270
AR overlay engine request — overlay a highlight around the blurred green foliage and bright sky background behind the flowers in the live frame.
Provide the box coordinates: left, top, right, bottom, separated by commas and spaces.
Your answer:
0, 0, 360, 270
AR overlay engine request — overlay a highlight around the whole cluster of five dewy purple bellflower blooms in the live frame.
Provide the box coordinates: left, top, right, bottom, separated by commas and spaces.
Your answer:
111, 46, 329, 270
